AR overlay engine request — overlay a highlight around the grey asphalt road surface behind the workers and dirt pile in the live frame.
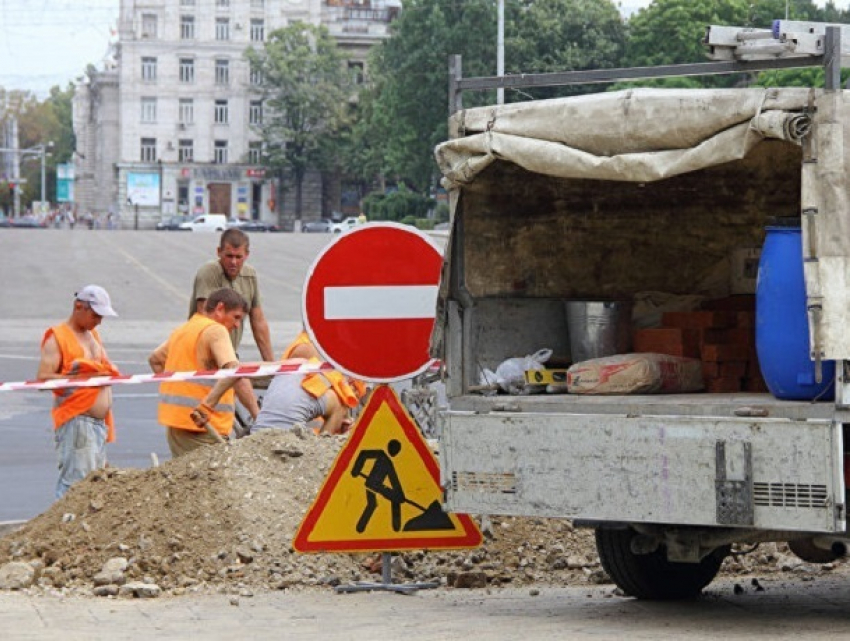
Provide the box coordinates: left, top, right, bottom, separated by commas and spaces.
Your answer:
0, 229, 331, 522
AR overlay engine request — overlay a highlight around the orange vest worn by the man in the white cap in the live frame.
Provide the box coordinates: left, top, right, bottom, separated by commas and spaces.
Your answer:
41, 323, 120, 443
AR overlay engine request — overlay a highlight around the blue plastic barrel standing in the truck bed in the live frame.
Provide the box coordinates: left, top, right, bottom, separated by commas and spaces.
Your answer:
756, 227, 835, 400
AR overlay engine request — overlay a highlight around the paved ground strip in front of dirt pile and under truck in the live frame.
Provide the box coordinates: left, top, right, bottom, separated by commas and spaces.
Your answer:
0, 580, 850, 641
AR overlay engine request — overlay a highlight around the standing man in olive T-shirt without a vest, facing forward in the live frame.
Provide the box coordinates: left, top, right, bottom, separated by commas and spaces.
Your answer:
189, 229, 274, 361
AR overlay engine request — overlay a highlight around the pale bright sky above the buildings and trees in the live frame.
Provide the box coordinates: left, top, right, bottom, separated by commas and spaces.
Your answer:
0, 0, 850, 99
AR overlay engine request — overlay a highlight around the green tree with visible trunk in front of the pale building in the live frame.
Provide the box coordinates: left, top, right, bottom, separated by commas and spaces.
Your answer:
245, 22, 350, 222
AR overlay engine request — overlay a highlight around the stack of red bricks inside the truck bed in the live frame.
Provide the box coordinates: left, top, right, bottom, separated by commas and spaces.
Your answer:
634, 295, 767, 393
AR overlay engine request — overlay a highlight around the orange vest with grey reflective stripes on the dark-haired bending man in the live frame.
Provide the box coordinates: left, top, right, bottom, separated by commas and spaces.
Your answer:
158, 314, 235, 436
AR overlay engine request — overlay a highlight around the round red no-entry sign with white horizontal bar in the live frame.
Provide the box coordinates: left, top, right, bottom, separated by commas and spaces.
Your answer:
302, 223, 443, 383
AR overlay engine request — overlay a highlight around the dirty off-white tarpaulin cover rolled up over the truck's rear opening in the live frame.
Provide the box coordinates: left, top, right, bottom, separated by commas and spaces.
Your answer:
435, 88, 850, 359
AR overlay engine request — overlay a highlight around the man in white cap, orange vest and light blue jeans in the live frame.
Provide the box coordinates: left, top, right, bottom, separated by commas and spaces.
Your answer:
36, 285, 119, 499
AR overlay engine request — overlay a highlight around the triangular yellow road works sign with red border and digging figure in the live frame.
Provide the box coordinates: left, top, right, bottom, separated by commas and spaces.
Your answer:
292, 385, 481, 552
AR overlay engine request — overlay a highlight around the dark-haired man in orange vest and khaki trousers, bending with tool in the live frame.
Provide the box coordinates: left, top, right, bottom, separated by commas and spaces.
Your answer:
148, 287, 259, 457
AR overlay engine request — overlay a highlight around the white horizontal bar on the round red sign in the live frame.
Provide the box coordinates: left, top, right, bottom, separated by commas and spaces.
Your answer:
325, 285, 437, 320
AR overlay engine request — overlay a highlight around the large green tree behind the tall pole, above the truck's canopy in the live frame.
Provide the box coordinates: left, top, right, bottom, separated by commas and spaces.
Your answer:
357, 0, 624, 192
